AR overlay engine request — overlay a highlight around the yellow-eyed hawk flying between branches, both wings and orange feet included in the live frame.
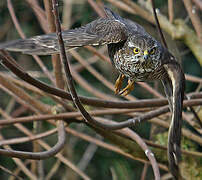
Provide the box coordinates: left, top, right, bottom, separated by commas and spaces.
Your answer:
0, 7, 184, 179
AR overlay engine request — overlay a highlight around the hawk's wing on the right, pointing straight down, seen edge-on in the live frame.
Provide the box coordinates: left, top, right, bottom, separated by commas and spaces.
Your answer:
162, 56, 185, 179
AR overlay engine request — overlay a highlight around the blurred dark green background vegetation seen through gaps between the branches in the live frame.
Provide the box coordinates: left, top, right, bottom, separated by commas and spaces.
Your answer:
0, 0, 202, 180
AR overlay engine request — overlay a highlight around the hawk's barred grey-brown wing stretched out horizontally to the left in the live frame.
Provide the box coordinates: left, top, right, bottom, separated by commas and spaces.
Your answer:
0, 9, 127, 55
